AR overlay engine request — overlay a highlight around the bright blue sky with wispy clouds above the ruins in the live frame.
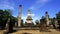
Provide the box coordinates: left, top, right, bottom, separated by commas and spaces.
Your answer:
0, 0, 60, 21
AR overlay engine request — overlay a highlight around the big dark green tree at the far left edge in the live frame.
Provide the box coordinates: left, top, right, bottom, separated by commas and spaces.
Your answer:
0, 10, 10, 29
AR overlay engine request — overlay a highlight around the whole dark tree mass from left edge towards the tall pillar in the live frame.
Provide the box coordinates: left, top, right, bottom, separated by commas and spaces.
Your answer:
0, 10, 17, 29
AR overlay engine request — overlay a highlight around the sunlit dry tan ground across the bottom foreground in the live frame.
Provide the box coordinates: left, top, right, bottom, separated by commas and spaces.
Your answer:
0, 29, 60, 34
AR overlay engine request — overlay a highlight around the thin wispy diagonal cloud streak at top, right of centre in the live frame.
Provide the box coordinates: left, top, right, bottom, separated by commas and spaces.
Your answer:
30, 0, 51, 10
